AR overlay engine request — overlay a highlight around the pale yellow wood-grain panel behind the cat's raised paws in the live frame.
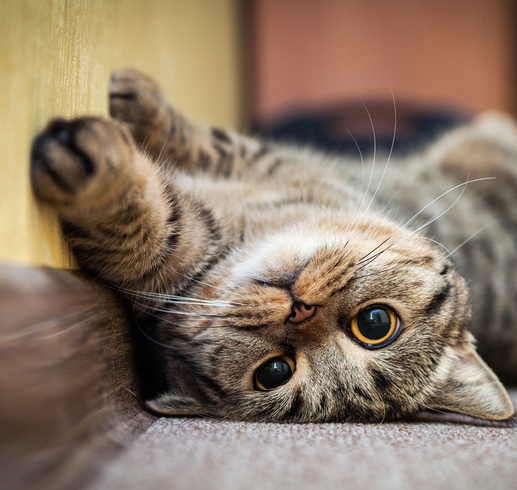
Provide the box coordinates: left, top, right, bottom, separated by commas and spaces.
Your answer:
0, 0, 241, 266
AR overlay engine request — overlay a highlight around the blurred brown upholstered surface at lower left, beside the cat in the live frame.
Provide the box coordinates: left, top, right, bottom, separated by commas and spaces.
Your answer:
0, 266, 154, 489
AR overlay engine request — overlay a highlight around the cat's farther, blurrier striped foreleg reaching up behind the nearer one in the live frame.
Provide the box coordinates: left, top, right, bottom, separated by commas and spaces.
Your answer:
109, 68, 275, 177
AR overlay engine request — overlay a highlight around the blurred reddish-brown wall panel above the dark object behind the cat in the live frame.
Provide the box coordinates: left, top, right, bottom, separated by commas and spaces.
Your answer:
252, 0, 517, 121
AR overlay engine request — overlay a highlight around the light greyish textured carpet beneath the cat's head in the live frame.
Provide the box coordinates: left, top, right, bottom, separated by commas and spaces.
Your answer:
92, 390, 517, 490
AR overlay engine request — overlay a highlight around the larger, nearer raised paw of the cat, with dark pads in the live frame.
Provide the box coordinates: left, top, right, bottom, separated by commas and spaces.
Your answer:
31, 117, 135, 206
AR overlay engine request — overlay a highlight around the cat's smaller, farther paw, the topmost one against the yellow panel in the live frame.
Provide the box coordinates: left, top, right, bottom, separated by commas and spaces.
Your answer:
109, 68, 168, 144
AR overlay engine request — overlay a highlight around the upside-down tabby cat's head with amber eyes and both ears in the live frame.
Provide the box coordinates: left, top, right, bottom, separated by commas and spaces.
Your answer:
147, 216, 514, 422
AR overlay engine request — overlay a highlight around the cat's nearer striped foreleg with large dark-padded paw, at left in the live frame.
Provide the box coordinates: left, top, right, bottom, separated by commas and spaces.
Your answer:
31, 117, 224, 291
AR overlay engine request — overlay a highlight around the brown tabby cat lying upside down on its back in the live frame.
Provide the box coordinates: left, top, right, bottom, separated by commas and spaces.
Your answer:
31, 68, 517, 423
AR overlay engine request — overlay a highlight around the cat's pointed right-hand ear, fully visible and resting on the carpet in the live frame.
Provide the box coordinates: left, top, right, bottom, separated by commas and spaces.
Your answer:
428, 344, 515, 420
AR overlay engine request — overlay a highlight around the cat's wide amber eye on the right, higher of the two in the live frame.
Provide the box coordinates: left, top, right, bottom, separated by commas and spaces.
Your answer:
350, 305, 400, 349
